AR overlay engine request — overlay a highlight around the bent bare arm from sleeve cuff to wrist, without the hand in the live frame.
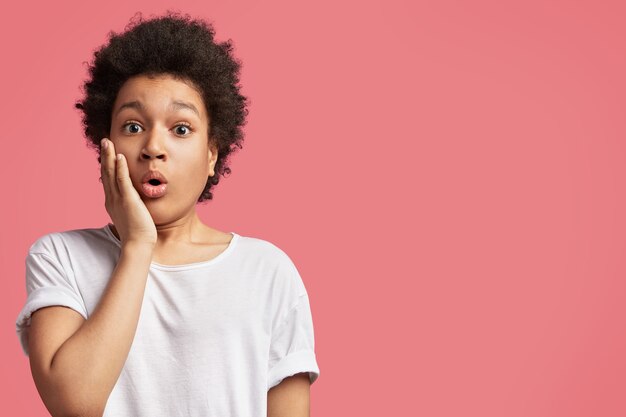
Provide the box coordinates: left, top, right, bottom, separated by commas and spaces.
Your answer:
29, 243, 153, 417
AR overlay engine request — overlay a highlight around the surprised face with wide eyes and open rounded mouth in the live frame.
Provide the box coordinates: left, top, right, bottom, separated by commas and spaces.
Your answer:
109, 75, 217, 224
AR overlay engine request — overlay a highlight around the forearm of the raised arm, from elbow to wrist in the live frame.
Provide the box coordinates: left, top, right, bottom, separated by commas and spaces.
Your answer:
50, 243, 153, 414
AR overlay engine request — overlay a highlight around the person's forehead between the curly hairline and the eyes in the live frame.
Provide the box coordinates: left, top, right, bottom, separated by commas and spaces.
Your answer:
113, 74, 206, 119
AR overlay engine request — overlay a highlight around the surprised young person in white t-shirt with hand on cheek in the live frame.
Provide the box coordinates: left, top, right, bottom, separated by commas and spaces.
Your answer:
16, 12, 319, 417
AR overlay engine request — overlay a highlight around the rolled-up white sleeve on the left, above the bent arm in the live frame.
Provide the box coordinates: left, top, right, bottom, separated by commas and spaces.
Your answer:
15, 250, 88, 356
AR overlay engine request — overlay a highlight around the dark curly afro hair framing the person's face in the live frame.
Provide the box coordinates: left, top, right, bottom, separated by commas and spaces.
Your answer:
75, 11, 249, 202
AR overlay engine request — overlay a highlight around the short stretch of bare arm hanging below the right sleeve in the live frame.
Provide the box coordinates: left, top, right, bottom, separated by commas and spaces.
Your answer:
267, 373, 311, 417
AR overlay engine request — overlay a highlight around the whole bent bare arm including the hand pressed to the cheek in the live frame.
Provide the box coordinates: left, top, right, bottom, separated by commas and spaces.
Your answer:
29, 139, 157, 417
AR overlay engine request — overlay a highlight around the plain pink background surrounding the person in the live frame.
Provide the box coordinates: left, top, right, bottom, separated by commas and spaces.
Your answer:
0, 0, 626, 417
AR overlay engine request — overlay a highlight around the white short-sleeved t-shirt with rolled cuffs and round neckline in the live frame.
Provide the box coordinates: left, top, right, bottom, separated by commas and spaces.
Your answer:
16, 225, 319, 417
